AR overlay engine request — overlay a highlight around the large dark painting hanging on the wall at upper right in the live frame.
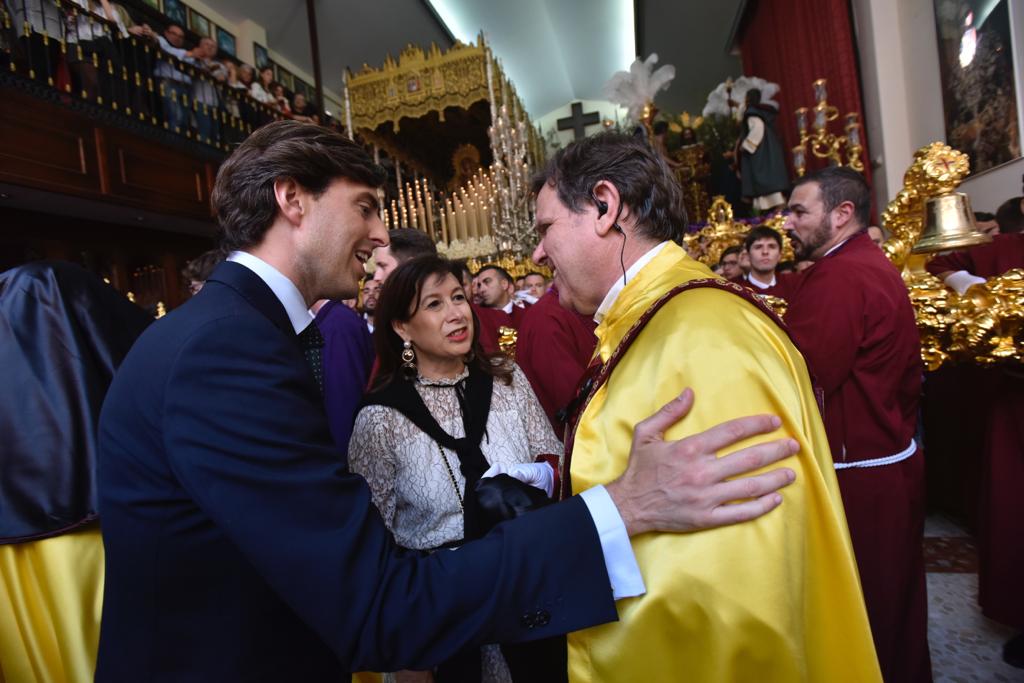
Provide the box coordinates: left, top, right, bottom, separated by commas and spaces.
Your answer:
934, 0, 1024, 173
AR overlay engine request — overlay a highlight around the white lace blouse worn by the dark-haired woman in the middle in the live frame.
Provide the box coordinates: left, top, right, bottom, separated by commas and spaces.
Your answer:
348, 366, 562, 550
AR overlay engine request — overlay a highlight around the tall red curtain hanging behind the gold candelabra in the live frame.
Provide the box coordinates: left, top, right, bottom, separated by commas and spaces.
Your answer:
737, 0, 870, 187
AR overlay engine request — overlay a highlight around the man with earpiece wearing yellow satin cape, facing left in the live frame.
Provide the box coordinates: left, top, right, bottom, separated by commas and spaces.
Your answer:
534, 133, 881, 683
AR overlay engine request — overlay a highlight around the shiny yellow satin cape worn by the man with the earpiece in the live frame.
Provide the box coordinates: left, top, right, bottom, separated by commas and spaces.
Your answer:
568, 244, 882, 683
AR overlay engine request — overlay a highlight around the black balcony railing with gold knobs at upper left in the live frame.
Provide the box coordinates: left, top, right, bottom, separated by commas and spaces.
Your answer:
0, 0, 296, 152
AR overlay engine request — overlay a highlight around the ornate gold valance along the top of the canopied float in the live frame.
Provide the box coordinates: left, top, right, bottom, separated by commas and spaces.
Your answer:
348, 33, 522, 131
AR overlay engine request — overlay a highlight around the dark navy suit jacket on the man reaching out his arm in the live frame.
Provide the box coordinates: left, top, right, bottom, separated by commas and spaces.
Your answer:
96, 262, 615, 683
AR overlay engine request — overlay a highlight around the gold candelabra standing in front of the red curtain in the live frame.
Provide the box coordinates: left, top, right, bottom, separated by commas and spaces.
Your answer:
793, 78, 864, 176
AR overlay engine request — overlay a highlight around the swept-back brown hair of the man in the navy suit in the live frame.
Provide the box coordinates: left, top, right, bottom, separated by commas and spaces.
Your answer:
211, 121, 386, 252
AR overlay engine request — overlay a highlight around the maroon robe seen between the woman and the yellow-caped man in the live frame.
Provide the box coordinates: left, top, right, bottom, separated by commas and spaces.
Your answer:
516, 289, 597, 438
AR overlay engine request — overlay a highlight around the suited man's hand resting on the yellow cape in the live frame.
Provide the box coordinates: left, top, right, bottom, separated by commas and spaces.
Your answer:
606, 389, 800, 536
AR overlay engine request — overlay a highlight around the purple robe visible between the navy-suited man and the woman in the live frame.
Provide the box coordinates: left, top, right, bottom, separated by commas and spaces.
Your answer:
314, 301, 374, 464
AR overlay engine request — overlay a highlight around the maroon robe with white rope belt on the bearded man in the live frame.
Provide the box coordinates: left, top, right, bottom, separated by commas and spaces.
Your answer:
785, 232, 932, 682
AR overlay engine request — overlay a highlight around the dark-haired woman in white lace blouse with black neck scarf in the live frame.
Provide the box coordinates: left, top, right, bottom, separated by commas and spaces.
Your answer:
348, 255, 565, 682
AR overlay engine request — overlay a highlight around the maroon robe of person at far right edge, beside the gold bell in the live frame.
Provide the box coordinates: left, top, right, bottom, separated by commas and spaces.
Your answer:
927, 233, 1024, 628
